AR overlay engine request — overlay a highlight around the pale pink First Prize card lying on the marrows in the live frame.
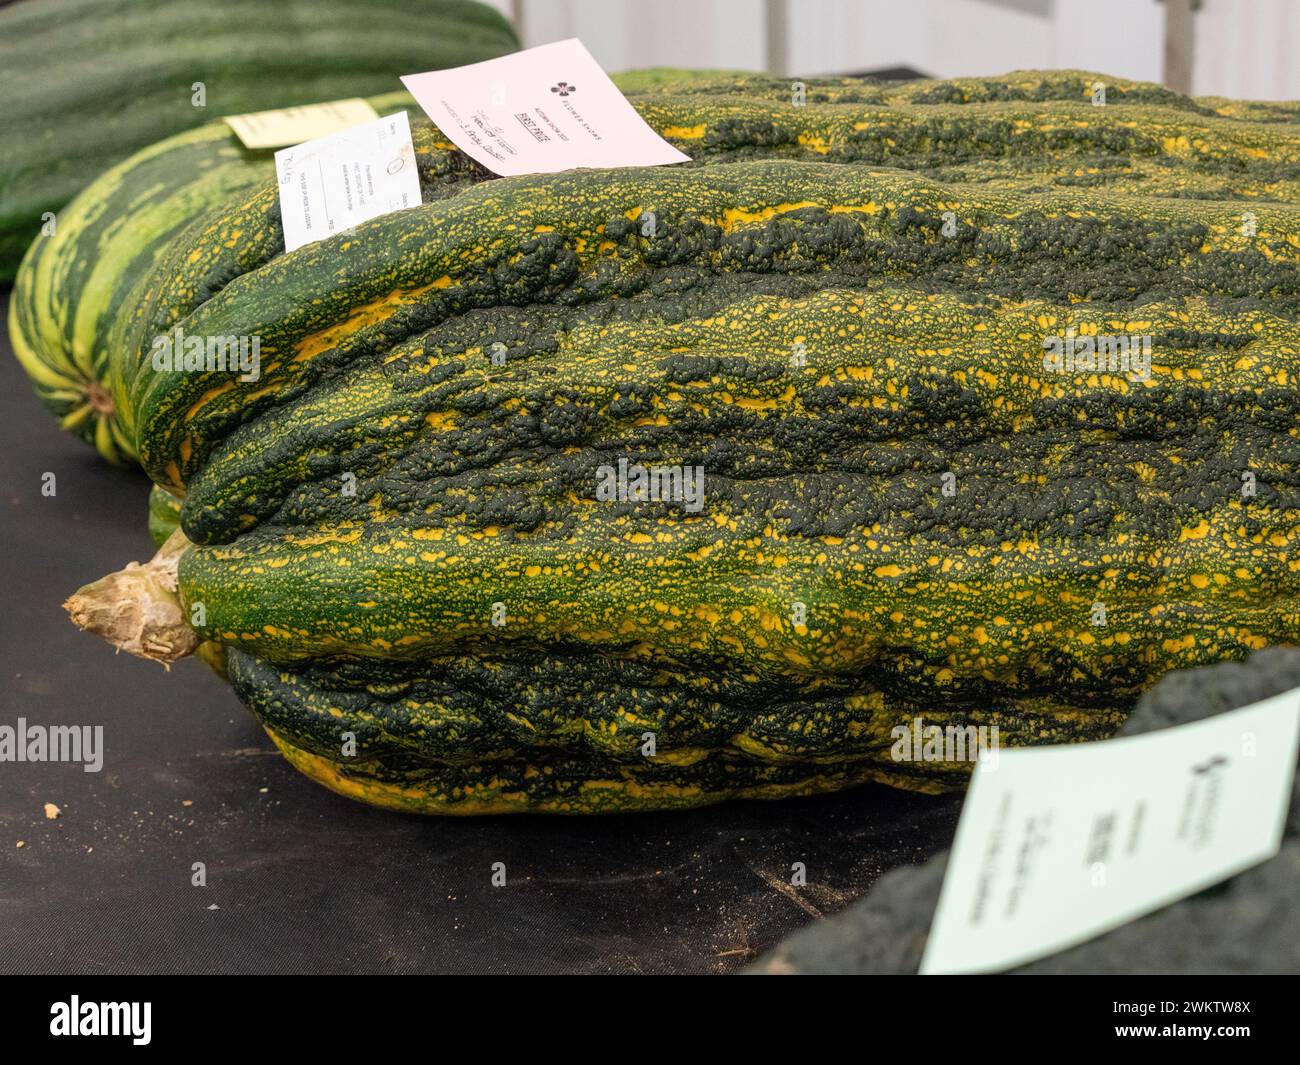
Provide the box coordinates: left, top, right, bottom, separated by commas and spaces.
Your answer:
402, 39, 690, 177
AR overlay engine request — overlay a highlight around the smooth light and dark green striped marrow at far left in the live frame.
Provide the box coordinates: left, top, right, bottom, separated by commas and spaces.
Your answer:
9, 92, 415, 463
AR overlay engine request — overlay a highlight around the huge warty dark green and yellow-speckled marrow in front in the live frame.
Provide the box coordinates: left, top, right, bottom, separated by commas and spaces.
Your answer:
86, 137, 1300, 813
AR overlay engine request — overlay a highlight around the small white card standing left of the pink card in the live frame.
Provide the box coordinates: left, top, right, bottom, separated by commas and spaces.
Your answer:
276, 111, 420, 251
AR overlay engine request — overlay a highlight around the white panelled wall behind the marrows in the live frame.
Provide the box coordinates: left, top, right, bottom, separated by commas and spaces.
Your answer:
480, 0, 1300, 99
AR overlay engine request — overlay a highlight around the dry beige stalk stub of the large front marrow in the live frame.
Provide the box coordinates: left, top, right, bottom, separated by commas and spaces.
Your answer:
64, 529, 199, 668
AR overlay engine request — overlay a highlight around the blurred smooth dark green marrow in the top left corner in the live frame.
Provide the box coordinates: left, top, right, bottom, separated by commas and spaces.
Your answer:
0, 0, 519, 282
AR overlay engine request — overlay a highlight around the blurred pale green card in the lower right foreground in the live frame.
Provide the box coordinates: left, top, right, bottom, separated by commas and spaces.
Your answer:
920, 689, 1300, 973
